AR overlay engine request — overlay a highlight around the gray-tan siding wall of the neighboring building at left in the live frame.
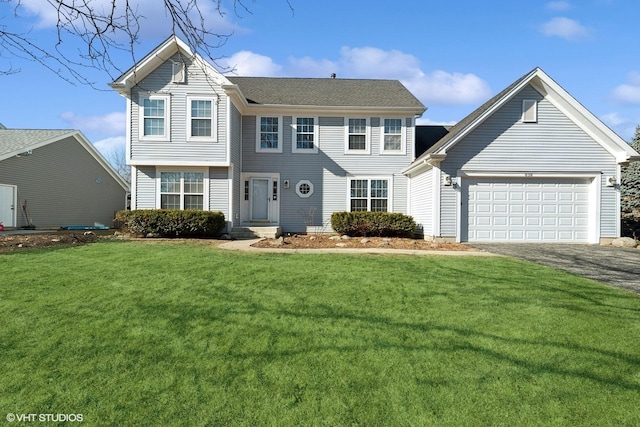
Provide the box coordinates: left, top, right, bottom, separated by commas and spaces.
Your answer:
0, 138, 126, 228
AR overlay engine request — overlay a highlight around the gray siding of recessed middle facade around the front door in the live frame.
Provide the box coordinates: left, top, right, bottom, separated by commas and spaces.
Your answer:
242, 116, 414, 232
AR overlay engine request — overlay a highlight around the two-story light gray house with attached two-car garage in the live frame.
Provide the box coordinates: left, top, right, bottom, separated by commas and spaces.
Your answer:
111, 37, 638, 242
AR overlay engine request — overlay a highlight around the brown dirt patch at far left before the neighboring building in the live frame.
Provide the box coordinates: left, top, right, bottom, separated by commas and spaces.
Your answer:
0, 231, 106, 253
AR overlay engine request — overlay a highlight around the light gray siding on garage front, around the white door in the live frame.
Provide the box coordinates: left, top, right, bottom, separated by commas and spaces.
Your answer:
441, 86, 619, 237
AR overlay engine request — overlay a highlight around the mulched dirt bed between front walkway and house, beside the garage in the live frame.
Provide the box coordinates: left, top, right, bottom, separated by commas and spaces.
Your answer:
252, 234, 476, 251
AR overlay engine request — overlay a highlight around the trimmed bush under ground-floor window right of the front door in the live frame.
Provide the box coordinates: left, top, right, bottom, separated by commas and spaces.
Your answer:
331, 211, 416, 237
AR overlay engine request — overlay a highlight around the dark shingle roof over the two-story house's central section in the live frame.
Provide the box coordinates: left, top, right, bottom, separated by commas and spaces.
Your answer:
227, 77, 425, 111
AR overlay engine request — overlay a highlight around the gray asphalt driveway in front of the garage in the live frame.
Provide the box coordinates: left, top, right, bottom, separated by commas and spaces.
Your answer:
470, 243, 640, 293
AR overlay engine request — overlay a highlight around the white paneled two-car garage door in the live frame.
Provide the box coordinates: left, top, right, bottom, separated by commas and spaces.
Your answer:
463, 178, 591, 243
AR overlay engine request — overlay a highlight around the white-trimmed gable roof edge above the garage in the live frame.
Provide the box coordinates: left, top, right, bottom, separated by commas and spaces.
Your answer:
405, 68, 640, 172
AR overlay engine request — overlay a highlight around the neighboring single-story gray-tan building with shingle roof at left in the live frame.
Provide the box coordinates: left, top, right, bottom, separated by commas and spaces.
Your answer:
0, 126, 129, 228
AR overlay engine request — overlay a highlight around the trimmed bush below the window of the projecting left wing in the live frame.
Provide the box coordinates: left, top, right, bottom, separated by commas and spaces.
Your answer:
116, 209, 226, 237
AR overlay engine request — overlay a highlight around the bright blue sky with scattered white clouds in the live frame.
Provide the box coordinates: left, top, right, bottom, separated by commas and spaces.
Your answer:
0, 0, 640, 159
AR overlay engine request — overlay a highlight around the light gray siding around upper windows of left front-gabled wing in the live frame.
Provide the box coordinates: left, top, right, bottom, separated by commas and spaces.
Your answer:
130, 55, 228, 164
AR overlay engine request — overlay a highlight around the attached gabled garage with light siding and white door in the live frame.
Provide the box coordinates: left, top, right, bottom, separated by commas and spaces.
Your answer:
403, 68, 640, 244
